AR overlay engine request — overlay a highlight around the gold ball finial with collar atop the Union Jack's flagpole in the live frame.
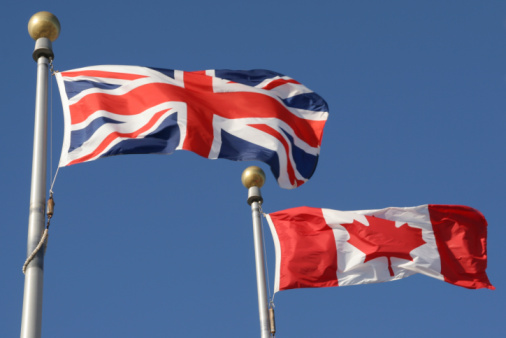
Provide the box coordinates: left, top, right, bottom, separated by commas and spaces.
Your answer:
28, 11, 61, 61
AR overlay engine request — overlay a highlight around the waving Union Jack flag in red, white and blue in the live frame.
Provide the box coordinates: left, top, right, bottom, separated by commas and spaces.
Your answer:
56, 65, 328, 189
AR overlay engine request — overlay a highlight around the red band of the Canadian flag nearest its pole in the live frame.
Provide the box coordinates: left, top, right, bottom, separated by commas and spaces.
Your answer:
269, 207, 339, 290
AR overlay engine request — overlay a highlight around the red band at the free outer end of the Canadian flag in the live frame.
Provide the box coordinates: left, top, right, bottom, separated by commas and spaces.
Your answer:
429, 204, 495, 290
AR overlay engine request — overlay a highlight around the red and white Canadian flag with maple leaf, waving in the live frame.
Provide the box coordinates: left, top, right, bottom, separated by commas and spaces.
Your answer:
266, 205, 495, 292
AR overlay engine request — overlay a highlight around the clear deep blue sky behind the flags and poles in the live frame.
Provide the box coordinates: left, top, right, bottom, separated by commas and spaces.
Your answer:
0, 0, 506, 338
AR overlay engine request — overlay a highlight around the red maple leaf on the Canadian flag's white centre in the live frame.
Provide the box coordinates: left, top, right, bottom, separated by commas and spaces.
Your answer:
341, 216, 426, 276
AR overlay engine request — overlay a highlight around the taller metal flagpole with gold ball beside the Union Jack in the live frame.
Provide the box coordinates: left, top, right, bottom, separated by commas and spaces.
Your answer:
21, 12, 60, 338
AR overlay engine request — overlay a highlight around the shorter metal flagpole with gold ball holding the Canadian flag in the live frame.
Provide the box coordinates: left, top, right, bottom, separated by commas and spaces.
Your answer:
241, 166, 271, 338
